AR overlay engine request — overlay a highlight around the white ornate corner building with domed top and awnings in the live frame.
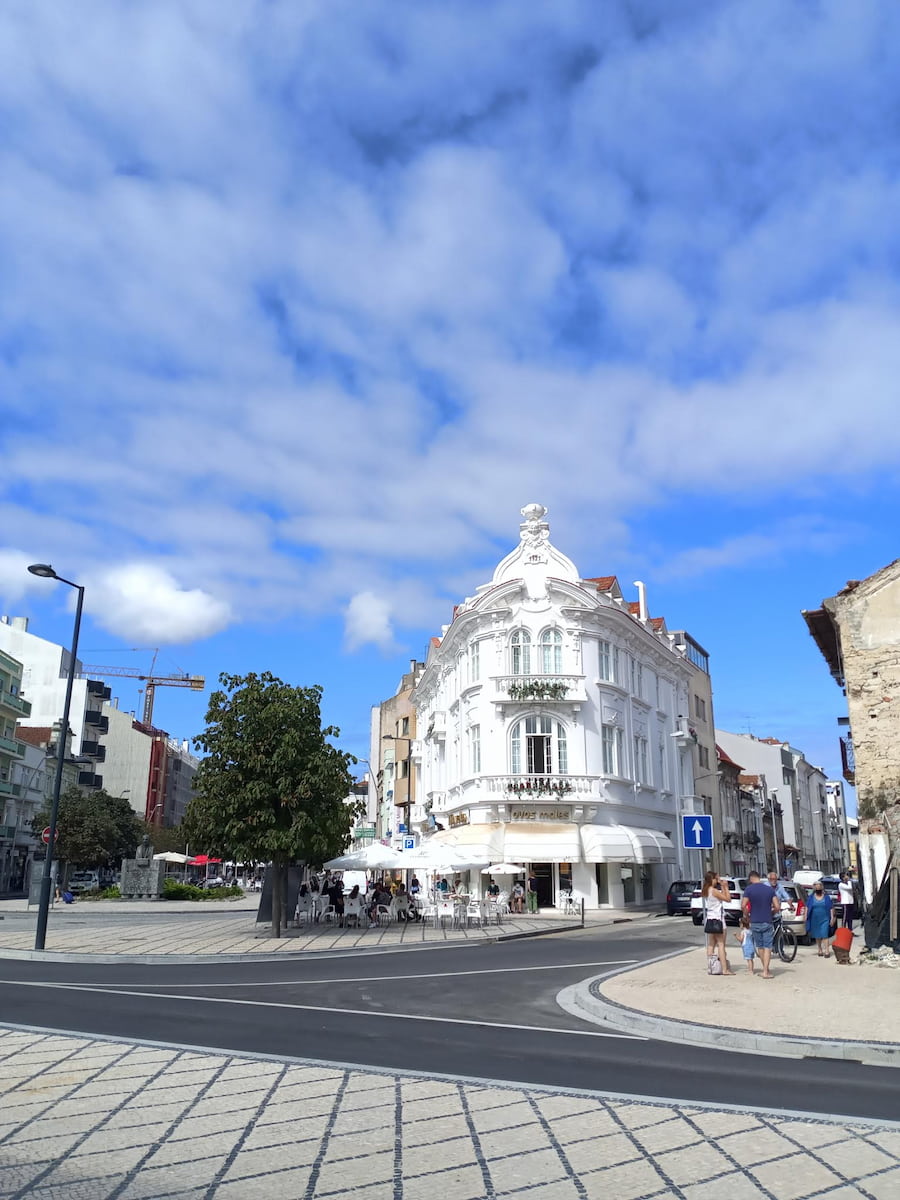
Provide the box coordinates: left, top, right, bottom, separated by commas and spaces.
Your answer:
413, 504, 702, 908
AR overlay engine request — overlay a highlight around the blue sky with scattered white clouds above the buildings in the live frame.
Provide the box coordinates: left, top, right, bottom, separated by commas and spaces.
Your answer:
0, 0, 900, 801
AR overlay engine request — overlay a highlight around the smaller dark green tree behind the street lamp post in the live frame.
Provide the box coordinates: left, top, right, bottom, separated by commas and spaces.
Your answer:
31, 787, 144, 866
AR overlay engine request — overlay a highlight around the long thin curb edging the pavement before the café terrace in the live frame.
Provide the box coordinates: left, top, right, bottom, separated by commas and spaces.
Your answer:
0, 925, 581, 967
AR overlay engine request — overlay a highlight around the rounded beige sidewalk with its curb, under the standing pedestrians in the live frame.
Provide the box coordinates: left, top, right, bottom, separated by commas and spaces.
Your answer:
559, 946, 900, 1065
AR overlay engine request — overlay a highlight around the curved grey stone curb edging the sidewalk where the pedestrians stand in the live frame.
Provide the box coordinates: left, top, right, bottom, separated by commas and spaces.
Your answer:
557, 949, 900, 1067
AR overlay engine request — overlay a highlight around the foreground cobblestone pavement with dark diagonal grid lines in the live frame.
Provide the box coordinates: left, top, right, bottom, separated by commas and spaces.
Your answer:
0, 1027, 900, 1200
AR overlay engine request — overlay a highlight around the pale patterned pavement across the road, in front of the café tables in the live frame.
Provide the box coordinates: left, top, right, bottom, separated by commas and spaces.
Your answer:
0, 913, 577, 956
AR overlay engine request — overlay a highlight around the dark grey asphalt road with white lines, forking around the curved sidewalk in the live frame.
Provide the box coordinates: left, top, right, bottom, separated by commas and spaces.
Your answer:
0, 920, 900, 1121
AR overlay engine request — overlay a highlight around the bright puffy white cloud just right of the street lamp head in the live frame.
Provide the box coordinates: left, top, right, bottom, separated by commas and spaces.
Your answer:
85, 563, 232, 644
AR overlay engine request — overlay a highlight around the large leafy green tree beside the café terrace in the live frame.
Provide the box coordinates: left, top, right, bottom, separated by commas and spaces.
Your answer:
184, 671, 358, 937
